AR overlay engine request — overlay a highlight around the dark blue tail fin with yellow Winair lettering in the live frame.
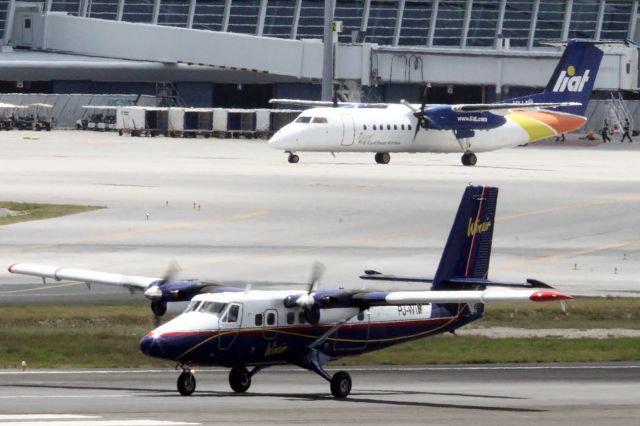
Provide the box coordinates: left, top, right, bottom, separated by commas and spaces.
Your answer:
431, 186, 498, 290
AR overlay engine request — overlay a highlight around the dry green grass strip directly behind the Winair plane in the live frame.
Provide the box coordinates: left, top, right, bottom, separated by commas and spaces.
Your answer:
0, 298, 640, 368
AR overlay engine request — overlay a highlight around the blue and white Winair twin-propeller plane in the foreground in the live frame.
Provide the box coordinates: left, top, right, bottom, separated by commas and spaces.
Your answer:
9, 186, 571, 398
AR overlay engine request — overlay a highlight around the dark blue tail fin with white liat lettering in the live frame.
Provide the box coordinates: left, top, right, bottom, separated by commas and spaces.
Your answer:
505, 40, 603, 116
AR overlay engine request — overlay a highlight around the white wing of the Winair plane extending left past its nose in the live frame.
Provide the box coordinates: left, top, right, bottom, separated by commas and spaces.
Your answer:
9, 263, 162, 291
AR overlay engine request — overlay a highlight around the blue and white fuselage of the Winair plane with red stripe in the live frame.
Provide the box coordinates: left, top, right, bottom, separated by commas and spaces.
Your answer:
141, 291, 482, 366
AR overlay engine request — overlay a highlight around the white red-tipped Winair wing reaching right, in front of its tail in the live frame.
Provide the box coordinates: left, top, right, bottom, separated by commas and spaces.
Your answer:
352, 288, 573, 306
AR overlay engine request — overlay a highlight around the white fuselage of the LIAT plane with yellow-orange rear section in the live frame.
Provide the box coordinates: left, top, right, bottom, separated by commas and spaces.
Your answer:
269, 104, 586, 153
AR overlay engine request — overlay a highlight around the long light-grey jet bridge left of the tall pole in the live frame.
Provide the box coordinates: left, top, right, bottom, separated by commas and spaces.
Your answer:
11, 6, 330, 79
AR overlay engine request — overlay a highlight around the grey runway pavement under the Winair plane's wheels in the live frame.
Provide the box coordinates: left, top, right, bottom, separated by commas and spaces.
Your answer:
0, 363, 640, 426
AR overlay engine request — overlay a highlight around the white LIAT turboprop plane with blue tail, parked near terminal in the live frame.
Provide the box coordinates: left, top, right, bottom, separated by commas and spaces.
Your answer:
269, 40, 603, 166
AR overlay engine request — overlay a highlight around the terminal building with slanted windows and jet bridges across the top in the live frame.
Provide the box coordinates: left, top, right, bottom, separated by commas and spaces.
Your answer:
0, 0, 640, 122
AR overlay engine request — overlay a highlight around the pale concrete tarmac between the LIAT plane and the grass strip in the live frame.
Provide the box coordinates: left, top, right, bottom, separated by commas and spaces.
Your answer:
0, 131, 640, 303
